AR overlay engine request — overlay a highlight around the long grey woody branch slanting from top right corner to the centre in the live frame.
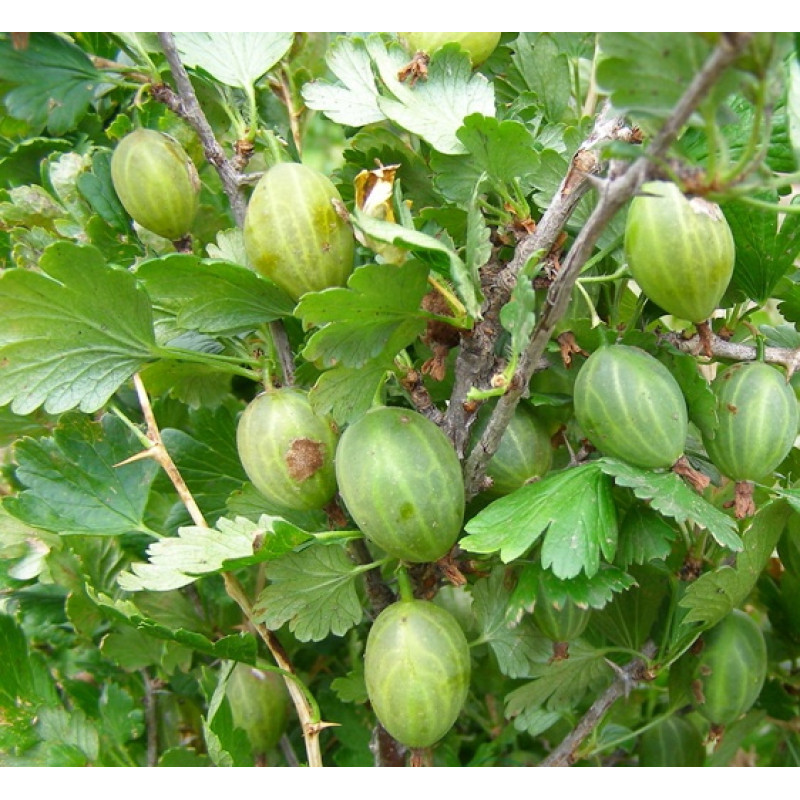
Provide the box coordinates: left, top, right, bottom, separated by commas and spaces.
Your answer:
464, 34, 750, 496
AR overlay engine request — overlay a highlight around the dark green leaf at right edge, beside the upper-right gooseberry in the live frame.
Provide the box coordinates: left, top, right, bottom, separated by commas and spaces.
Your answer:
722, 192, 800, 303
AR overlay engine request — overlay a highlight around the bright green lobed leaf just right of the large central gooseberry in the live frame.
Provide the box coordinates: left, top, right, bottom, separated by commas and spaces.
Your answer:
459, 463, 617, 578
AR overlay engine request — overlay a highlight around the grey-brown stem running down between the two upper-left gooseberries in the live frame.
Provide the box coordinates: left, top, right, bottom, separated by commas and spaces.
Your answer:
154, 33, 294, 385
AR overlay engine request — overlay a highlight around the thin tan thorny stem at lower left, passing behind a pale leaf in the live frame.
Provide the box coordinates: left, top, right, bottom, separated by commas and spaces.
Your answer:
133, 374, 331, 767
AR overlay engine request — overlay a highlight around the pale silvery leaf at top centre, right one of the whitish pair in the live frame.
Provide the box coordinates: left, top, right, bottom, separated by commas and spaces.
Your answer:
370, 40, 495, 155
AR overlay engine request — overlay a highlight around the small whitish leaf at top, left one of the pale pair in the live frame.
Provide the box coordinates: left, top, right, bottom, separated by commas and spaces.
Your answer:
303, 36, 386, 128
